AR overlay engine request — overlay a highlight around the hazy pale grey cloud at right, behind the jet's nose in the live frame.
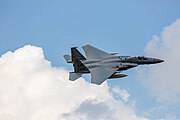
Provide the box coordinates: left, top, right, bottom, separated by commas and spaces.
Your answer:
139, 20, 180, 118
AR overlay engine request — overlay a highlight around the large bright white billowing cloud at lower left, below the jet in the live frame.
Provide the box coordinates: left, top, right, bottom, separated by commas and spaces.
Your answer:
0, 45, 146, 120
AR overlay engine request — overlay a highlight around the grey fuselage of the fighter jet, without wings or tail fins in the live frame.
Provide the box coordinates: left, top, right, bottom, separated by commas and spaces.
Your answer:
79, 56, 163, 73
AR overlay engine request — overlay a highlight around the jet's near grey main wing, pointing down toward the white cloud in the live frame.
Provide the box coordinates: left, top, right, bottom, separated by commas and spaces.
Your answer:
89, 66, 118, 85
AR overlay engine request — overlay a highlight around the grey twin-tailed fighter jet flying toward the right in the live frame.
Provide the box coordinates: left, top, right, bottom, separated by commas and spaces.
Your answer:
64, 44, 164, 85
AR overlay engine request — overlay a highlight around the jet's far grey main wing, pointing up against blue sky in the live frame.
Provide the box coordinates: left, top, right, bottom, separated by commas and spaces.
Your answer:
82, 44, 113, 59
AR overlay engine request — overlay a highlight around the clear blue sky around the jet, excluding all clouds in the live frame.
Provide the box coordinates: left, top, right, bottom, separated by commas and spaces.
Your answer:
0, 0, 180, 119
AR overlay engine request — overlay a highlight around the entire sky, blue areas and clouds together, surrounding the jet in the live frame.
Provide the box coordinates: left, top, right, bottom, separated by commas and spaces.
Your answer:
0, 0, 180, 120
